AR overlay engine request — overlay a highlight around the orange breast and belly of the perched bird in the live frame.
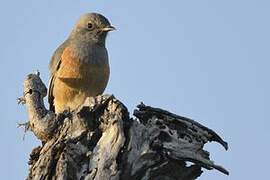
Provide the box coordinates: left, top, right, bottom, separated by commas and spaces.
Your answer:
53, 48, 109, 112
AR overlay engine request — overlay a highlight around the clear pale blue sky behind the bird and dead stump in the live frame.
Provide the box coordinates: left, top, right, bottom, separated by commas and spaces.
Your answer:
0, 0, 270, 180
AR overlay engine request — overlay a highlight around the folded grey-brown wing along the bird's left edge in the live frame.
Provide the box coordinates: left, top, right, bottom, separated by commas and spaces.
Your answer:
48, 40, 68, 111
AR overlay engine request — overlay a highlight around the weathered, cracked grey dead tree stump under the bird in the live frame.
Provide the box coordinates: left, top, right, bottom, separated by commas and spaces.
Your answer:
21, 74, 229, 180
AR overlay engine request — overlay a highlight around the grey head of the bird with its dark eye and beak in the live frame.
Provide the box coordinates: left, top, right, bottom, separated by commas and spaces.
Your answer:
70, 13, 115, 44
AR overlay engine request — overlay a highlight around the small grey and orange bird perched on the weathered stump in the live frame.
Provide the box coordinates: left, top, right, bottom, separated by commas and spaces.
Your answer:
48, 13, 115, 113
